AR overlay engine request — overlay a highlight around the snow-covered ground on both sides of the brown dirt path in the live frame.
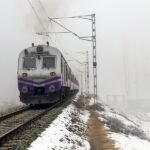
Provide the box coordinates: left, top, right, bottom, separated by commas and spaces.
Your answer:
28, 95, 150, 150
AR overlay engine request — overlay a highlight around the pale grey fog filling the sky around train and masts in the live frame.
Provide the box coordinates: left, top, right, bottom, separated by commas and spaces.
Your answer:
0, 0, 150, 111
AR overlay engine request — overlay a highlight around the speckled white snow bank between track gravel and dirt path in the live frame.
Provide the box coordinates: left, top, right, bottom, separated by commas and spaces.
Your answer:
28, 95, 90, 150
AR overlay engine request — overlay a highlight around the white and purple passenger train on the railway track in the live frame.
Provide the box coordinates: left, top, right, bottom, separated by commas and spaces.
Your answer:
17, 42, 79, 106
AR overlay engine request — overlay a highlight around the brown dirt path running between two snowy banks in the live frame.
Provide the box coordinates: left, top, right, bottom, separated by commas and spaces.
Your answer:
85, 99, 117, 150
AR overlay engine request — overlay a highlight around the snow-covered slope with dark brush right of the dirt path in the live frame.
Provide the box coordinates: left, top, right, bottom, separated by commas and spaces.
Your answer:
97, 100, 150, 150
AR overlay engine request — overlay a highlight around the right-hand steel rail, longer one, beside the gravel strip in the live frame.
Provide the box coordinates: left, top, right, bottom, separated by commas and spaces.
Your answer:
0, 101, 61, 147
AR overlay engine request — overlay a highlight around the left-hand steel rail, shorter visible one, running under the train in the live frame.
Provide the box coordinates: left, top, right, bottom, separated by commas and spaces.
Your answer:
0, 106, 29, 121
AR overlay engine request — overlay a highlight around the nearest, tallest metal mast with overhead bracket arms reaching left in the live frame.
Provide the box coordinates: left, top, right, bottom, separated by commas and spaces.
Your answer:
37, 14, 97, 103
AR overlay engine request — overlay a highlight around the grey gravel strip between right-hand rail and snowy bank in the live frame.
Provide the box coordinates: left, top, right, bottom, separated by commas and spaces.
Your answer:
0, 100, 70, 150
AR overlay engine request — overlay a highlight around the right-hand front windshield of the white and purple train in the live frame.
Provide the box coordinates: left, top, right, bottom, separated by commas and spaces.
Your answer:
43, 56, 56, 69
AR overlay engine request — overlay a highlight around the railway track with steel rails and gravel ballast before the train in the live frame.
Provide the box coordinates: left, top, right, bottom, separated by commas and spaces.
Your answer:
0, 101, 70, 150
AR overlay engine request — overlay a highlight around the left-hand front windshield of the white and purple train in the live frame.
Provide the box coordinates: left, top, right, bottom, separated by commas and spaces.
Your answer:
23, 57, 36, 69
